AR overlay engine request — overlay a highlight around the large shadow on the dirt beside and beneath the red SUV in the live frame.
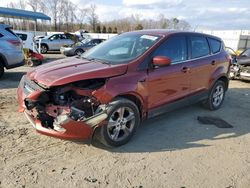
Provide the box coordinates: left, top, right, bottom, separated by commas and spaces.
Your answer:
93, 88, 250, 153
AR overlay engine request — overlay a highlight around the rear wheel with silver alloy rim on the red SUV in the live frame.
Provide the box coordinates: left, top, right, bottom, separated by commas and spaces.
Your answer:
204, 80, 226, 110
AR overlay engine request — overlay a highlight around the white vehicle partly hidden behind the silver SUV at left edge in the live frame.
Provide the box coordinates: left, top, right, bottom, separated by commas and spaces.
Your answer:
14, 31, 34, 50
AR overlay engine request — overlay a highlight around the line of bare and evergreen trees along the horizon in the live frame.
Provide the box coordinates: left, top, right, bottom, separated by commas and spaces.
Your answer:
3, 0, 191, 33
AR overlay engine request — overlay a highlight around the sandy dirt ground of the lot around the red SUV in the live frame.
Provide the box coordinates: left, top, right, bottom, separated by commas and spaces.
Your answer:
0, 55, 250, 188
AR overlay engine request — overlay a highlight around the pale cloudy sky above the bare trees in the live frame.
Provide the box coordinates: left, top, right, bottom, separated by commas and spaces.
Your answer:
0, 0, 250, 30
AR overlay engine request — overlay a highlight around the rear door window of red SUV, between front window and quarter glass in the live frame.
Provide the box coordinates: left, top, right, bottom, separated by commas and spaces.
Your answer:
189, 36, 210, 59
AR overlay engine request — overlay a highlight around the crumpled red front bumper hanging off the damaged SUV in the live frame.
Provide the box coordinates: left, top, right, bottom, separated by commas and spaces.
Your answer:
17, 75, 107, 140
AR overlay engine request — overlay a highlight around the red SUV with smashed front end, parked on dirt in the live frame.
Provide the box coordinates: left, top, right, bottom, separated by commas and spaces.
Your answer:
18, 30, 230, 146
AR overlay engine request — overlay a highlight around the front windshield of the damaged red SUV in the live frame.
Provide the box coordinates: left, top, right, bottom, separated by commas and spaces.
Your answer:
82, 34, 160, 64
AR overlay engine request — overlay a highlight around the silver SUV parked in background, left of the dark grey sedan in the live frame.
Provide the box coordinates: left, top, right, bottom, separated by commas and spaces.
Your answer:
36, 34, 76, 54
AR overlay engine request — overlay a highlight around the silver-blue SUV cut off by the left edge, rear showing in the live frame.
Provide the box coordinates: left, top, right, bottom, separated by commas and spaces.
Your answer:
0, 24, 24, 78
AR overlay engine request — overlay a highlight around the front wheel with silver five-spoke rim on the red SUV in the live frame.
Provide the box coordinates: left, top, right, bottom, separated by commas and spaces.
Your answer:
95, 98, 140, 147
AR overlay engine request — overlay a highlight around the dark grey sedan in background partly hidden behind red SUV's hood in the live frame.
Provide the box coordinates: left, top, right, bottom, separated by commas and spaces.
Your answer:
60, 39, 105, 56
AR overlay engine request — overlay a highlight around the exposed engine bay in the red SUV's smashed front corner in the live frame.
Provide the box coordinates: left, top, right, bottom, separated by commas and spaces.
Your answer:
24, 78, 106, 131
